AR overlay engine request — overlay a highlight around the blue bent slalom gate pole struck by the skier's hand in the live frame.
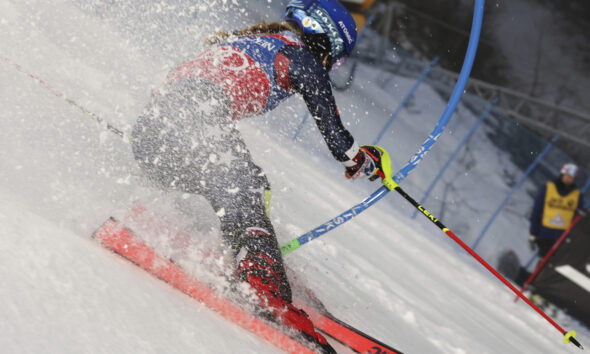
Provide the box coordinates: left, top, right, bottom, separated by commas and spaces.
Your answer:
281, 0, 484, 255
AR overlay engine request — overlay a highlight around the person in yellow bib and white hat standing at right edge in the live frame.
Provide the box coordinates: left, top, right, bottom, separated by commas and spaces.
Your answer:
529, 163, 584, 257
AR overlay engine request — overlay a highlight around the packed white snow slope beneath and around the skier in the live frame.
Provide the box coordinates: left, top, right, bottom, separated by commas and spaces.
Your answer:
0, 0, 590, 353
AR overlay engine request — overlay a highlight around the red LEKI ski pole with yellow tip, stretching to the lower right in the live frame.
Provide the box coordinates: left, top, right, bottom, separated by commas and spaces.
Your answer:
381, 175, 584, 349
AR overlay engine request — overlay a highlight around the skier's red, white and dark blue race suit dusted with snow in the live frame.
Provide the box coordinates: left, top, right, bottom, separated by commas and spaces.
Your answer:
132, 32, 358, 299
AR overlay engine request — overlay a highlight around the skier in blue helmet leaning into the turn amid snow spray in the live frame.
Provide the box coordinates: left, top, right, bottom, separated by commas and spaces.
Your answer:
132, 0, 382, 351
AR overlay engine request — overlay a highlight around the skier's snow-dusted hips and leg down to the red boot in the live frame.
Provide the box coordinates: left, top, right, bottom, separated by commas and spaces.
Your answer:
132, 79, 291, 302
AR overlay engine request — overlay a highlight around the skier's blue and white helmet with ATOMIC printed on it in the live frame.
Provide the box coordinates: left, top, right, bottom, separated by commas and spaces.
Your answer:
283, 0, 357, 62
